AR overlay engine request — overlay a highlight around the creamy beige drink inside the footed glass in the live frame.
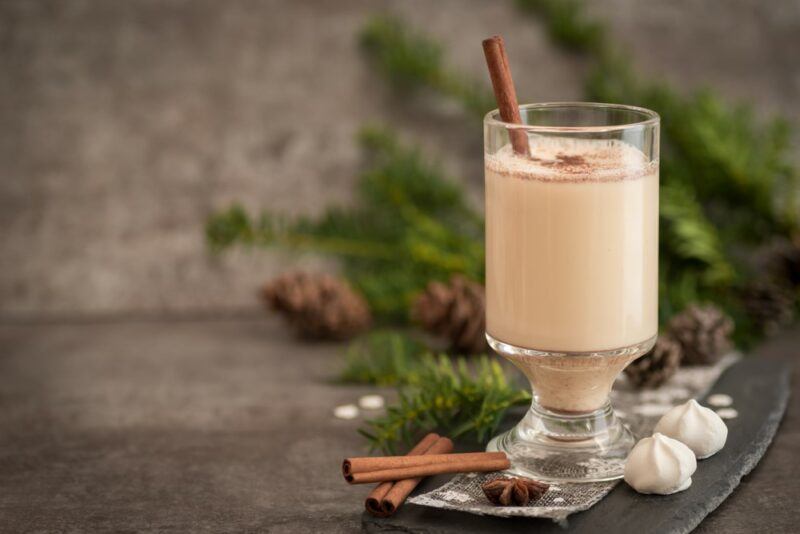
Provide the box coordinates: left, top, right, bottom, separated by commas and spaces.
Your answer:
486, 135, 658, 412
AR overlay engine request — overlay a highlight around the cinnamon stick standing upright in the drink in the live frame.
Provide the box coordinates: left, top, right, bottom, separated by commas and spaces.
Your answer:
483, 35, 531, 157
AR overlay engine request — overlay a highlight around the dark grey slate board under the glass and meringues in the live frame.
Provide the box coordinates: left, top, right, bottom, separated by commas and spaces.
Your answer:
362, 358, 791, 534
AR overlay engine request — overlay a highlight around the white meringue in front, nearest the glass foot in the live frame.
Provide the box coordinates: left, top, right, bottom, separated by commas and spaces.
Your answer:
625, 432, 697, 495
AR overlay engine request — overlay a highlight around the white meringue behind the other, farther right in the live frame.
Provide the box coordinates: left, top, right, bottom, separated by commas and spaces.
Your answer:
655, 399, 728, 459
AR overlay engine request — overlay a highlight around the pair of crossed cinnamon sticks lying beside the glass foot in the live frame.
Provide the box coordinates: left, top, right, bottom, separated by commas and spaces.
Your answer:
352, 433, 510, 517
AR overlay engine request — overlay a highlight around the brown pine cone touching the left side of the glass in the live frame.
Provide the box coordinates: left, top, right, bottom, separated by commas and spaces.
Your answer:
411, 276, 486, 354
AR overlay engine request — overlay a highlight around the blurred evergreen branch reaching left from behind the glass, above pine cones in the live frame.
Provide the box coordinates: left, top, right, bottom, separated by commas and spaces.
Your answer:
206, 127, 484, 323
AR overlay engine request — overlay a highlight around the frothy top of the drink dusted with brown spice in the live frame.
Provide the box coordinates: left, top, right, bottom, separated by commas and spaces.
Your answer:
485, 136, 658, 182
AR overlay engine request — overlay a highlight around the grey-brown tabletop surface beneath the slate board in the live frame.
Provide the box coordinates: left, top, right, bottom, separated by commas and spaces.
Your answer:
0, 320, 800, 534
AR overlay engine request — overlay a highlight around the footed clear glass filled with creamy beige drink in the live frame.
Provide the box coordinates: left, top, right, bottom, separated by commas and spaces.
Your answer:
484, 103, 659, 482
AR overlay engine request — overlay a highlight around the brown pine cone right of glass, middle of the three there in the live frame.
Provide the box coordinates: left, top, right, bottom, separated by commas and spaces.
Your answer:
669, 304, 733, 365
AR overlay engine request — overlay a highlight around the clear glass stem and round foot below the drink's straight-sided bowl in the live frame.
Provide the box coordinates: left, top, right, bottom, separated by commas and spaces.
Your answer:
486, 334, 655, 482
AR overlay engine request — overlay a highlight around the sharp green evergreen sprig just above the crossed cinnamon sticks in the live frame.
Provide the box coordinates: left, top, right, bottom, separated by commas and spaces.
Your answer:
360, 354, 531, 454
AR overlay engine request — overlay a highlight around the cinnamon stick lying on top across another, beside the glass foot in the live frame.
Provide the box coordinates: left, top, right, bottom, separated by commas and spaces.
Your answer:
342, 452, 511, 484
